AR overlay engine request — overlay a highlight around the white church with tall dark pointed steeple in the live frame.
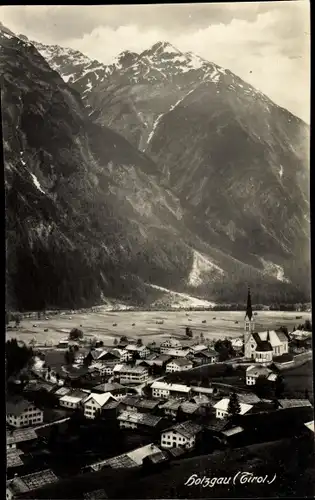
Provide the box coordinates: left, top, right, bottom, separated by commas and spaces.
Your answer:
244, 289, 289, 363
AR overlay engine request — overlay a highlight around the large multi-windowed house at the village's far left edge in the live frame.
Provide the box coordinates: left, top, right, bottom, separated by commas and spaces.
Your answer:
6, 396, 44, 428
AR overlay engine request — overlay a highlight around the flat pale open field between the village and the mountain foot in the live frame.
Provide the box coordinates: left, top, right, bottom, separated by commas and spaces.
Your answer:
6, 310, 311, 345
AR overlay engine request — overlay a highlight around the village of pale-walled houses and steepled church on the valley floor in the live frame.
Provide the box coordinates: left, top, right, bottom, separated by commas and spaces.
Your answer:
6, 290, 314, 500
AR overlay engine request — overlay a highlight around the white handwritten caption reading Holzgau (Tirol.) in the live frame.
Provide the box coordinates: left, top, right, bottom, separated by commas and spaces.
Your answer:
185, 471, 277, 488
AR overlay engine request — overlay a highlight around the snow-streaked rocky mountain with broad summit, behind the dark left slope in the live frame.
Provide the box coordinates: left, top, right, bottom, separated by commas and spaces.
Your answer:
38, 42, 310, 296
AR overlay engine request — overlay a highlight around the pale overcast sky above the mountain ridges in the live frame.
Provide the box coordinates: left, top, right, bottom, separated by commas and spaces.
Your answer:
0, 0, 310, 122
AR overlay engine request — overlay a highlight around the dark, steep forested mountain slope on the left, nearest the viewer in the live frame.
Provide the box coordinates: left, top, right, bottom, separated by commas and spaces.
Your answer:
0, 30, 200, 309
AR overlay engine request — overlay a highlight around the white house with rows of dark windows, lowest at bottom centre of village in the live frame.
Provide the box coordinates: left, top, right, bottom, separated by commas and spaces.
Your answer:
161, 421, 203, 449
